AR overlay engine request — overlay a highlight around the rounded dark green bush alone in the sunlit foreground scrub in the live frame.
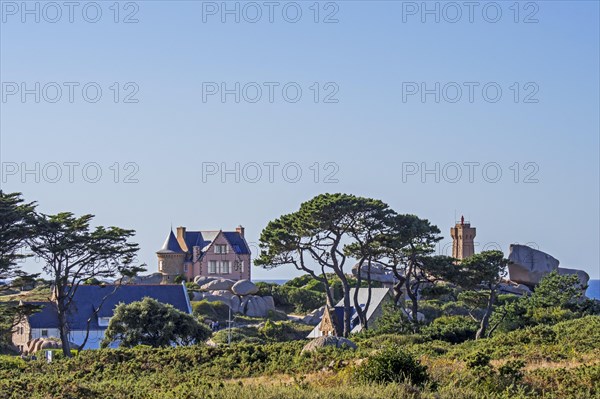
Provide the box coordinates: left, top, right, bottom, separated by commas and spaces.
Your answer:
355, 346, 429, 386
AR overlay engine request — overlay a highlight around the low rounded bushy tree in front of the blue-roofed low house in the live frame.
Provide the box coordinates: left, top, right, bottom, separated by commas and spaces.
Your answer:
102, 298, 211, 348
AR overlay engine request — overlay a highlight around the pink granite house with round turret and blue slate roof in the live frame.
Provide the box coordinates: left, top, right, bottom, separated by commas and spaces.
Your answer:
156, 226, 251, 282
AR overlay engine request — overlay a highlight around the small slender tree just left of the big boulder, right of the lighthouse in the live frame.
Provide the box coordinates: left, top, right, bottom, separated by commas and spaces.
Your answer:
461, 251, 509, 339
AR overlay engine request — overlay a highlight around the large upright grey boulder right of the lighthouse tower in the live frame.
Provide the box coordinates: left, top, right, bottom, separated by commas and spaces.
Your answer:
508, 244, 559, 287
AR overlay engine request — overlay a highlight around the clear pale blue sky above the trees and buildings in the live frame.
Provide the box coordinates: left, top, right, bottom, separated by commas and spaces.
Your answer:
0, 1, 600, 279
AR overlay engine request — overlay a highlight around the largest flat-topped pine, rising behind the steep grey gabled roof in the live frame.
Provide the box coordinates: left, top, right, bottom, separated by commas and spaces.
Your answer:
255, 194, 389, 336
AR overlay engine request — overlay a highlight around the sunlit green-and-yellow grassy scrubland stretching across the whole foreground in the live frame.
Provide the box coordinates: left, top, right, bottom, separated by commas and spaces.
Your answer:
0, 316, 600, 399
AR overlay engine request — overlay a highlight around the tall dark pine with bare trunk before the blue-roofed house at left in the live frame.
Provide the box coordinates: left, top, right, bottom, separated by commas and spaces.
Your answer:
28, 212, 138, 356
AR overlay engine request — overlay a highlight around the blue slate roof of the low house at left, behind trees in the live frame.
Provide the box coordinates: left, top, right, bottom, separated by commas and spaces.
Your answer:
24, 284, 191, 331
